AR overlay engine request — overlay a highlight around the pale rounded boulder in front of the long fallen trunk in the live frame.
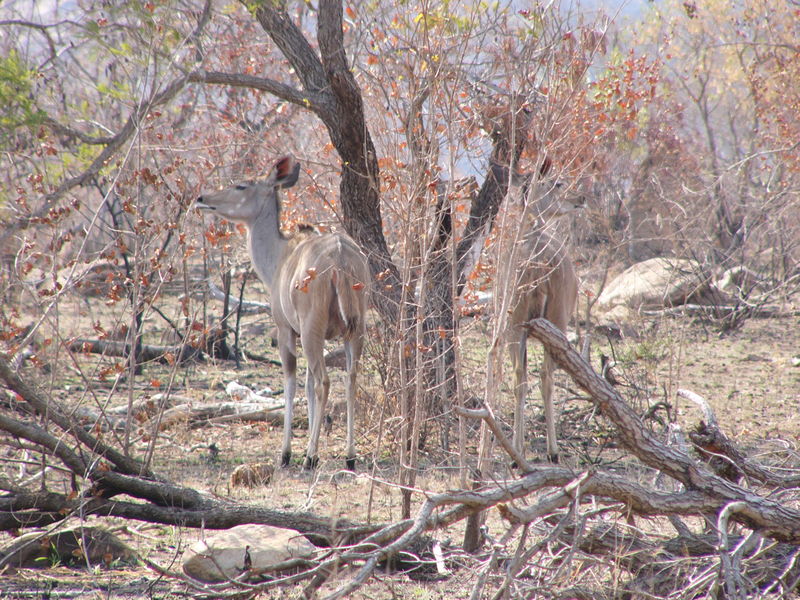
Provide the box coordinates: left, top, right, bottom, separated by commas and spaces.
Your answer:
183, 525, 315, 583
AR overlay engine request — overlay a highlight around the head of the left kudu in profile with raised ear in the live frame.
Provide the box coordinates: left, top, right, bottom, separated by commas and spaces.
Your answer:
195, 156, 300, 225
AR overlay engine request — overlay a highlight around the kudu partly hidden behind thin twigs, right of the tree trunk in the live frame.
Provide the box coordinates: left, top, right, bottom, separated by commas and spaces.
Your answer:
508, 163, 583, 462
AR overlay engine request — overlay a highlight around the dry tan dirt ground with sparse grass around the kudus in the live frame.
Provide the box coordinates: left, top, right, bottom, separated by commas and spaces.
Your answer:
0, 284, 800, 599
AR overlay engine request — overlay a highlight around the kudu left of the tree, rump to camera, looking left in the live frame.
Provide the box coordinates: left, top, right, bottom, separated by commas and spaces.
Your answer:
196, 157, 369, 470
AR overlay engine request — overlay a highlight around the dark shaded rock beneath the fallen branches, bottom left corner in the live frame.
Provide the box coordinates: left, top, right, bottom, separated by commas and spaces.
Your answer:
0, 527, 136, 569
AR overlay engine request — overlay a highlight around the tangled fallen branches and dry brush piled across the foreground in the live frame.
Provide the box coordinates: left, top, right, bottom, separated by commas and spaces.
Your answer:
0, 320, 800, 598
